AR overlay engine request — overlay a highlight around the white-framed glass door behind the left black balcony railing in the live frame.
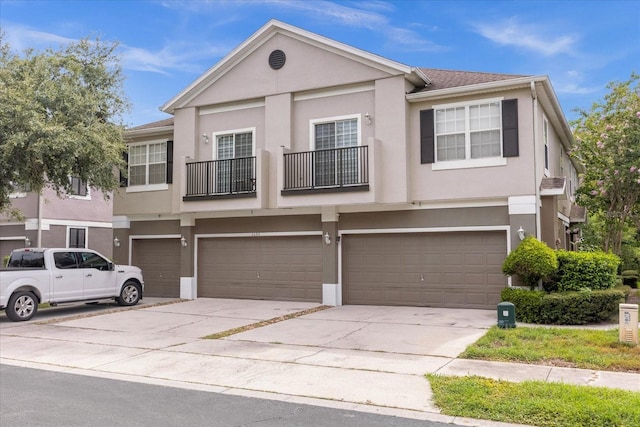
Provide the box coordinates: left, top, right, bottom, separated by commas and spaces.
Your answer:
214, 129, 255, 193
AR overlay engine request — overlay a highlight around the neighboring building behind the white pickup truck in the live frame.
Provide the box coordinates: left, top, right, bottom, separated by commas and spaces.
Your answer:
0, 178, 113, 257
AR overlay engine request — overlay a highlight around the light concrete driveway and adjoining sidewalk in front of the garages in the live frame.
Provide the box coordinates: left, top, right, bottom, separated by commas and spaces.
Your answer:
0, 298, 640, 426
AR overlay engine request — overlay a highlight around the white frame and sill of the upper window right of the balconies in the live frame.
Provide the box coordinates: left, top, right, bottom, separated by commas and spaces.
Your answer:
431, 97, 507, 171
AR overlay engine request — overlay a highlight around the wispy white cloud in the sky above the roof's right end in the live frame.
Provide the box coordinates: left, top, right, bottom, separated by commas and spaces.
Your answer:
475, 17, 578, 56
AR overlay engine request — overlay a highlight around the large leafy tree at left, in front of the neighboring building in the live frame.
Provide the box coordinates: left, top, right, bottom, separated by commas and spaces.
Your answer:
0, 33, 129, 214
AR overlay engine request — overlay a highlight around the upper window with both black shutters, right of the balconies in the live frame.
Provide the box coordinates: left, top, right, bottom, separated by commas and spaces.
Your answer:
420, 98, 519, 170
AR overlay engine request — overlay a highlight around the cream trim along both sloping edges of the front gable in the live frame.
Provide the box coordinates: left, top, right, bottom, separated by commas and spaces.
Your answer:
160, 19, 429, 114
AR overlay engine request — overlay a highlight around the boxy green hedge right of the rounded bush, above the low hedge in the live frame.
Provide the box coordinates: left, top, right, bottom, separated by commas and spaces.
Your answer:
554, 250, 620, 292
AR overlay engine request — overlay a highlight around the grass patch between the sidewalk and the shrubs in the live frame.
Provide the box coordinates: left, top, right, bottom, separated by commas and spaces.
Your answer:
460, 326, 640, 373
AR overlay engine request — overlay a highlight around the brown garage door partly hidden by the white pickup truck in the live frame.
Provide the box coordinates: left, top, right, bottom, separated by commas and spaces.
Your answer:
131, 239, 180, 298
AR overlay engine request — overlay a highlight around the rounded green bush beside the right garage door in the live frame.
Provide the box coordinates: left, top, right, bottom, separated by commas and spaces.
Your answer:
502, 236, 558, 290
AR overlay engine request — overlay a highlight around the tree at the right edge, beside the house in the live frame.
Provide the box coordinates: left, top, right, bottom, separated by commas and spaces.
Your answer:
570, 73, 640, 255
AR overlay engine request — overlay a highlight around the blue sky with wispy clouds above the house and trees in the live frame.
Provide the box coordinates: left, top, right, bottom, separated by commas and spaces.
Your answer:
0, 0, 640, 126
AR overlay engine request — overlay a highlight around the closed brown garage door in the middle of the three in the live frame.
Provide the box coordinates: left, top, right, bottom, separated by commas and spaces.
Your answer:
198, 236, 322, 302
